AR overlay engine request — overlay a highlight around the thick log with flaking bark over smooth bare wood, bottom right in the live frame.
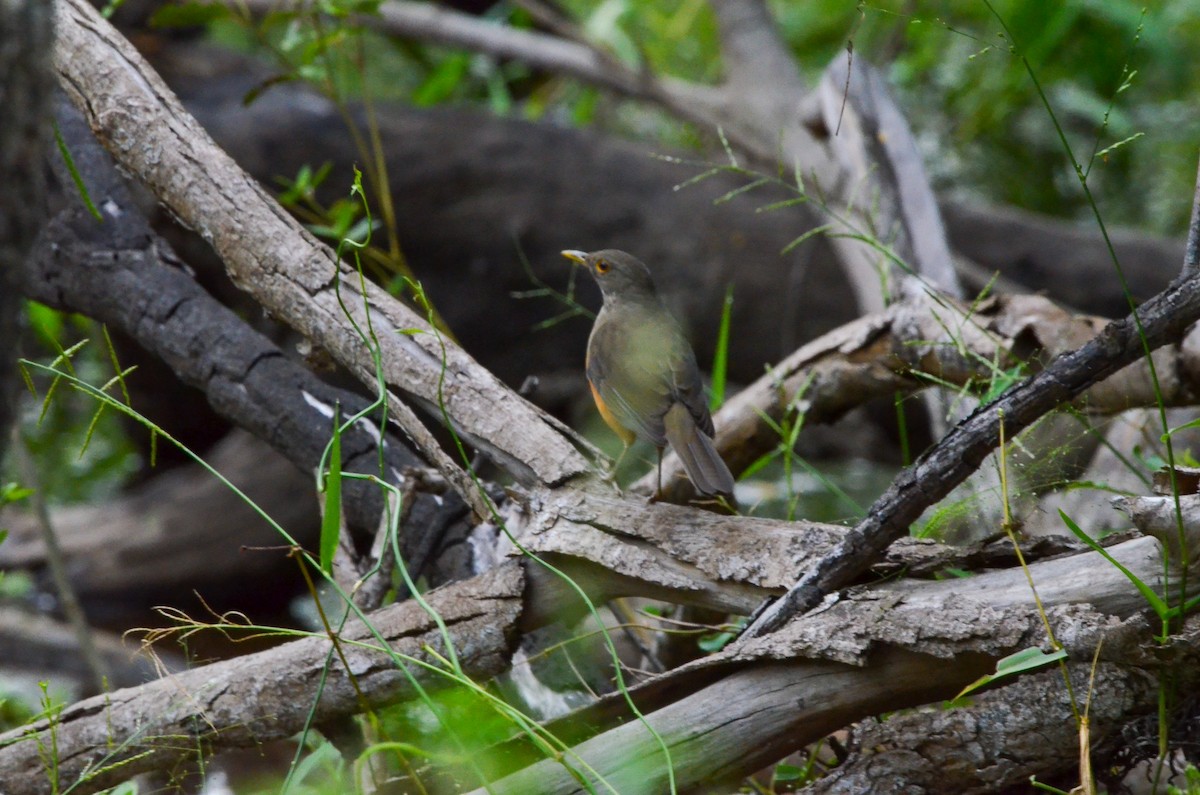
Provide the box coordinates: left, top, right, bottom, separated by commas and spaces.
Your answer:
472, 538, 1195, 795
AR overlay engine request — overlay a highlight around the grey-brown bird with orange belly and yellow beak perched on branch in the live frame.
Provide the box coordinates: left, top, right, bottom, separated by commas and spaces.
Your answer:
563, 249, 733, 497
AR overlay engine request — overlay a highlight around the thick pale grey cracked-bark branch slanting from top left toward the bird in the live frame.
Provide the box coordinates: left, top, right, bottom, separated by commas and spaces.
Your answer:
55, 0, 590, 516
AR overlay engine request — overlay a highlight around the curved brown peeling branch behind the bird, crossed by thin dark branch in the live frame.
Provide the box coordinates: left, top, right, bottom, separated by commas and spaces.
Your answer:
634, 289, 1200, 502
